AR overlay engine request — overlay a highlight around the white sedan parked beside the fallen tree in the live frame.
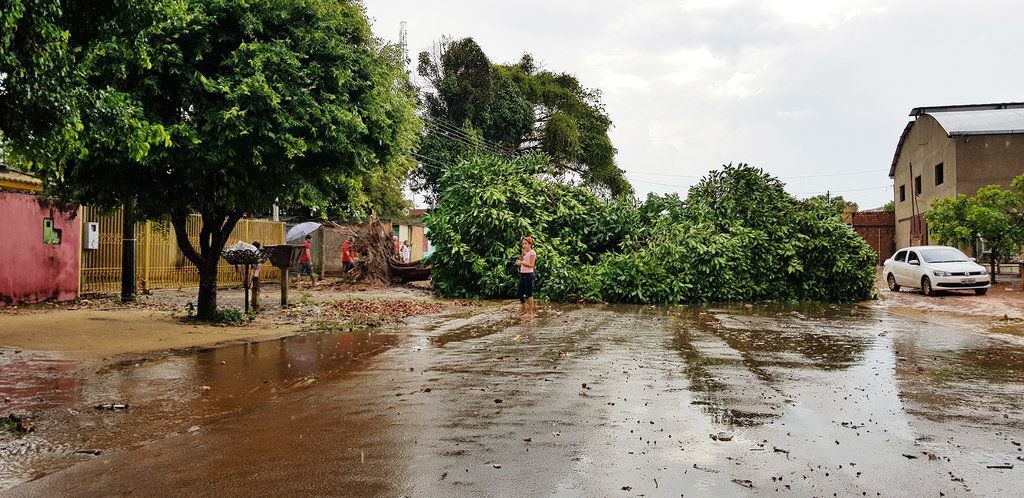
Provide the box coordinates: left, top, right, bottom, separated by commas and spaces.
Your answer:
882, 246, 989, 296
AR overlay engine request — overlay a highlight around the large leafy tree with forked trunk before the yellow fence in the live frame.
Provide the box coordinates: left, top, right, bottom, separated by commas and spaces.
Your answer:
5, 0, 419, 318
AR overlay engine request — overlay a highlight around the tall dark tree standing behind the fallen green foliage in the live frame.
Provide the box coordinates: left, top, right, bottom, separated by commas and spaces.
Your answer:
416, 38, 633, 203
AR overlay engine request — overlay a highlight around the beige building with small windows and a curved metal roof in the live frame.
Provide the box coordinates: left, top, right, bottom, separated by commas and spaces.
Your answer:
889, 102, 1024, 249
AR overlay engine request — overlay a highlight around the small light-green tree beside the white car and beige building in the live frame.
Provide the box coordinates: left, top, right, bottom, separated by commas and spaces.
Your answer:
925, 175, 1024, 284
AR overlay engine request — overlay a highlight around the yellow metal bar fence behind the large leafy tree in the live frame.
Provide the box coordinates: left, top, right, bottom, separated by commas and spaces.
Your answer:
79, 206, 285, 294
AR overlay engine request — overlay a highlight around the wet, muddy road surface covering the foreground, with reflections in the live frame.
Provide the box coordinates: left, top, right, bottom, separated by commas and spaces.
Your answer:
0, 305, 1024, 496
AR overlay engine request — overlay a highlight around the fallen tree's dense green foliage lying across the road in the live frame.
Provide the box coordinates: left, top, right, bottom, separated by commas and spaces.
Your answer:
425, 155, 876, 303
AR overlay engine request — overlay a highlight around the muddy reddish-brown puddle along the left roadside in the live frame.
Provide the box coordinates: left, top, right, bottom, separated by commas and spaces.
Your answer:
0, 331, 398, 489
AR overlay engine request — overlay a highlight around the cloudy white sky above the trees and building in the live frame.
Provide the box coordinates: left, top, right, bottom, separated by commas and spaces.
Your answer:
366, 0, 1024, 209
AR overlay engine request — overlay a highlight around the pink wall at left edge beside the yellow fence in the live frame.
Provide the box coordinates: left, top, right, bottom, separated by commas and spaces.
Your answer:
0, 193, 82, 306
